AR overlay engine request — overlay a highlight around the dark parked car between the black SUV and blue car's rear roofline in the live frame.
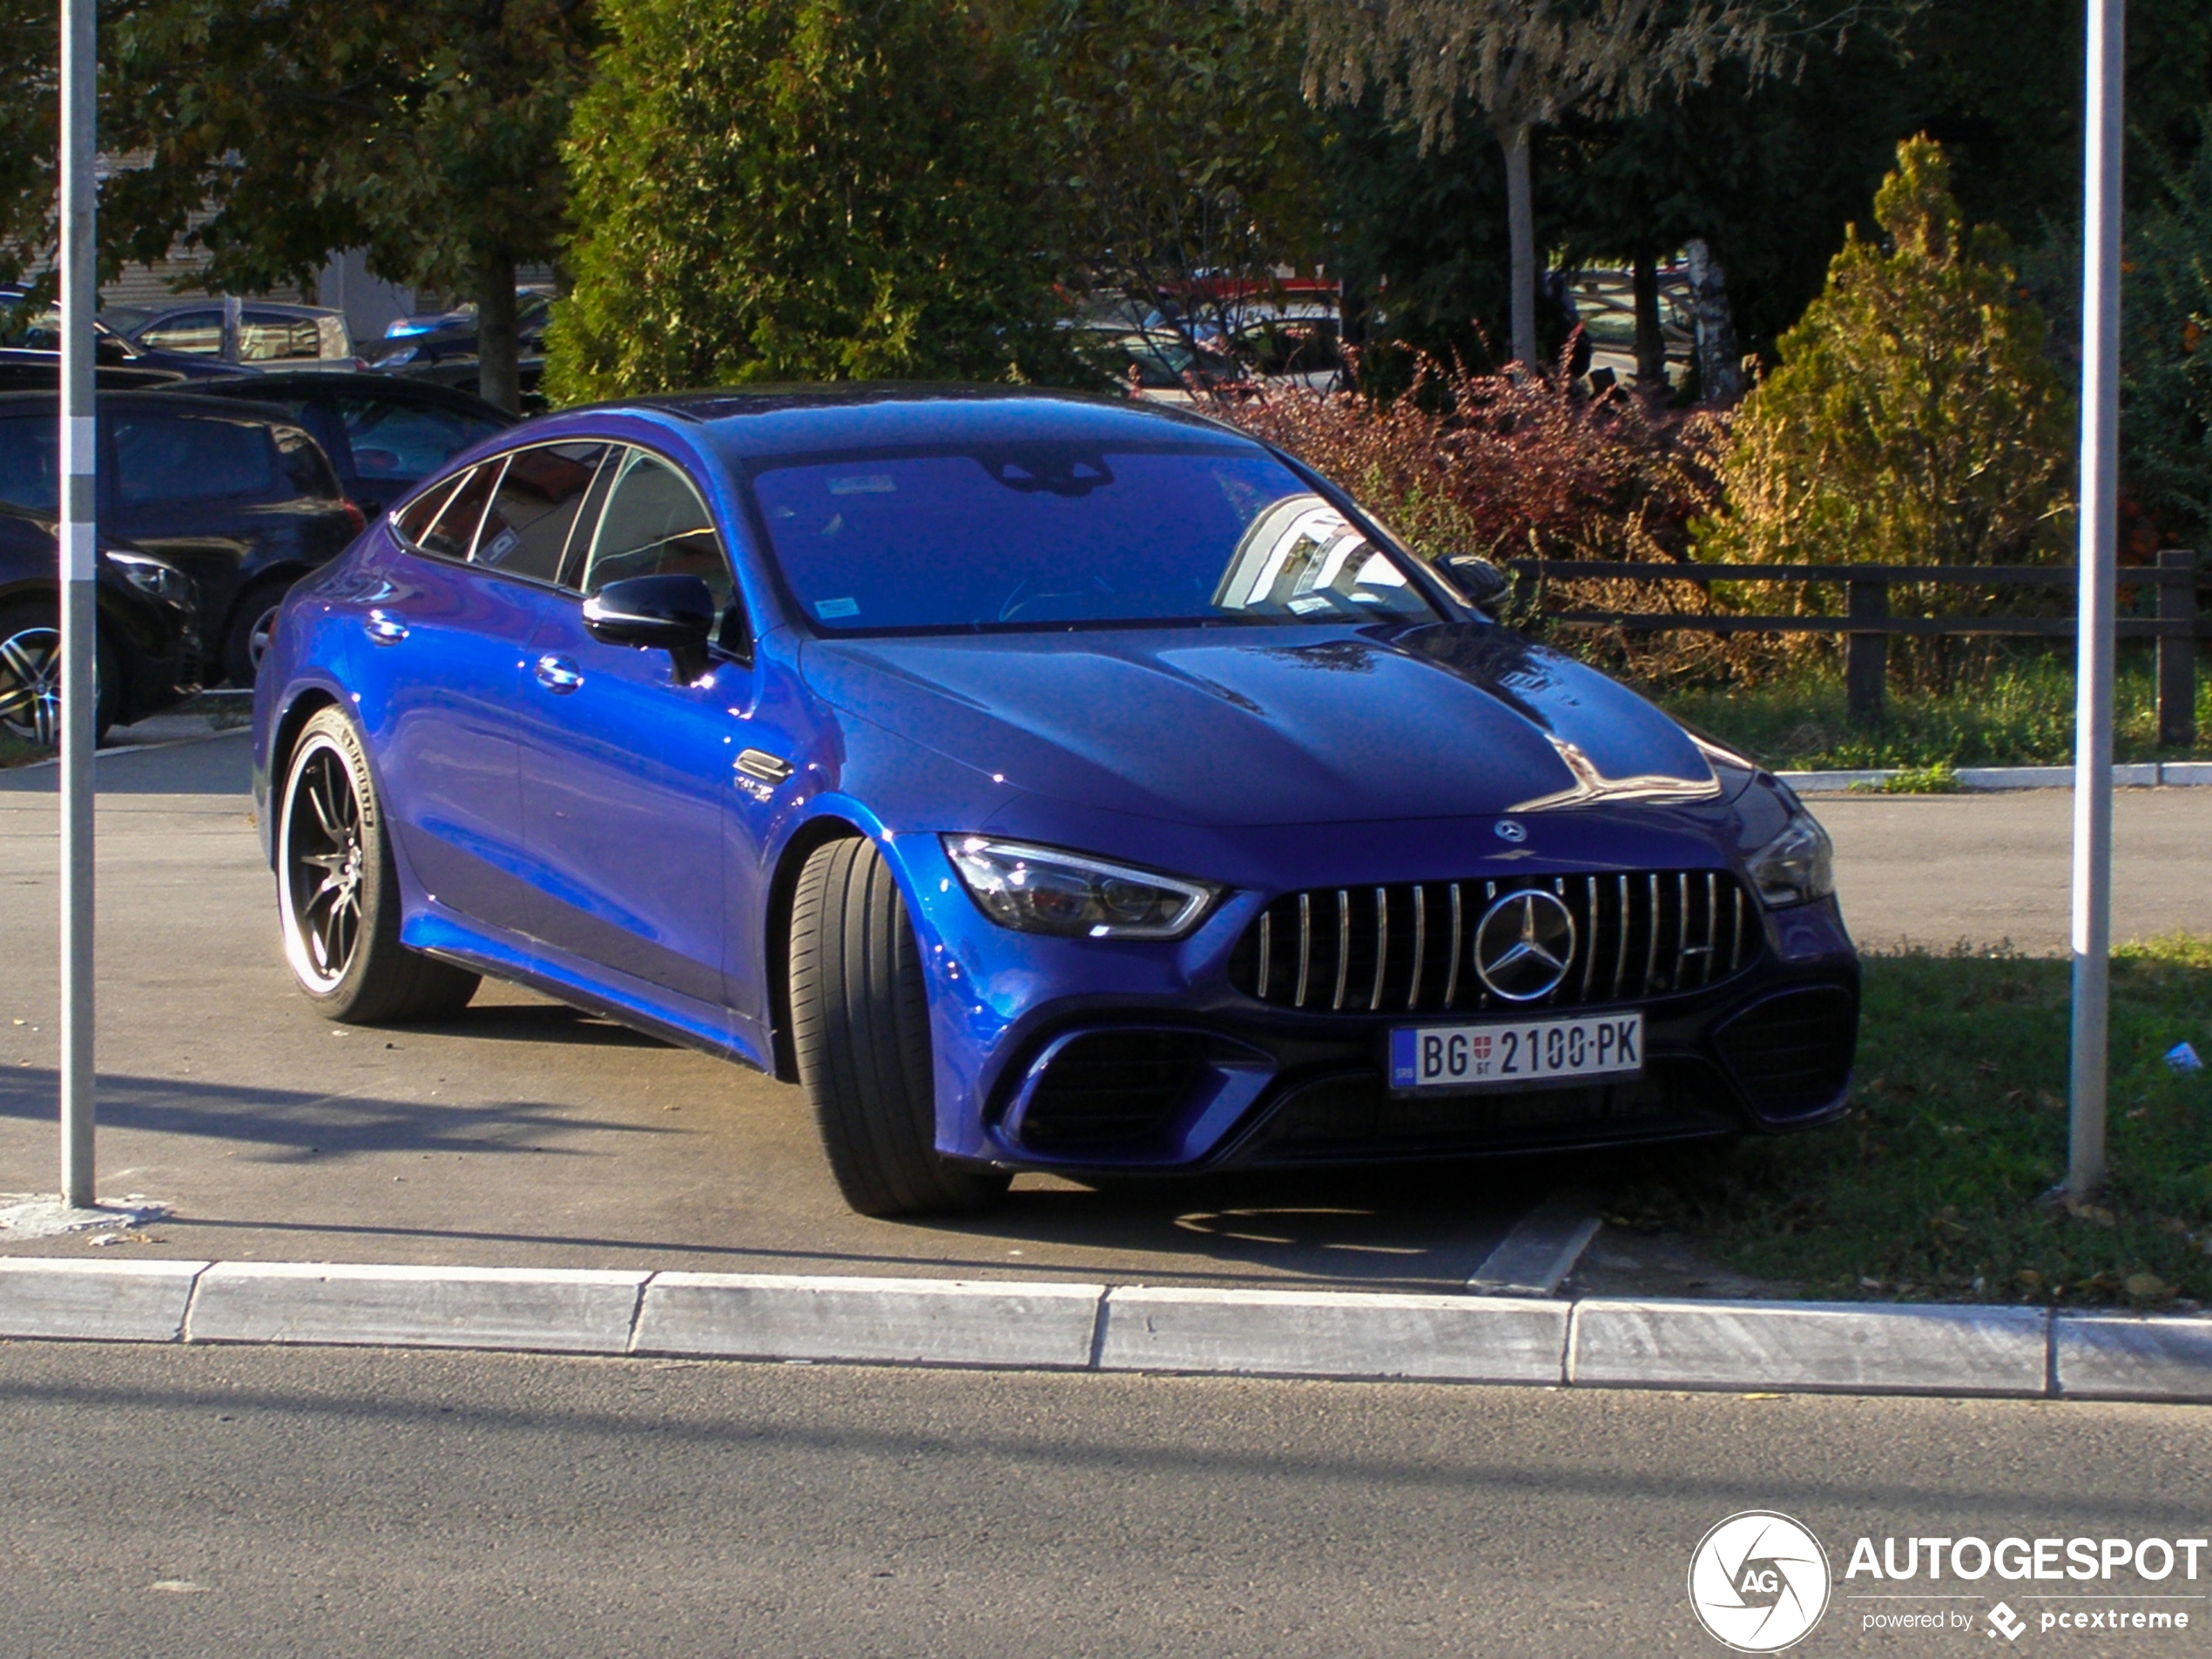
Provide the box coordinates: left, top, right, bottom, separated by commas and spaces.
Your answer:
170, 372, 516, 517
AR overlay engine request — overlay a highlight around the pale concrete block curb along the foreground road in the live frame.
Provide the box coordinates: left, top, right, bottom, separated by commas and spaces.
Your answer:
12, 1257, 2212, 1400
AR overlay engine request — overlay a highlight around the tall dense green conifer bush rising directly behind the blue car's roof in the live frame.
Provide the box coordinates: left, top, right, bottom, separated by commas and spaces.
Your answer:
546, 0, 1075, 402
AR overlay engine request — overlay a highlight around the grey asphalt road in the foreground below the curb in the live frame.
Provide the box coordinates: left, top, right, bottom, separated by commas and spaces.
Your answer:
0, 1343, 2212, 1659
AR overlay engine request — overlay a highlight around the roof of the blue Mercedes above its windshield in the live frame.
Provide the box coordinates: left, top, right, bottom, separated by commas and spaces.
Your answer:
556, 381, 1258, 460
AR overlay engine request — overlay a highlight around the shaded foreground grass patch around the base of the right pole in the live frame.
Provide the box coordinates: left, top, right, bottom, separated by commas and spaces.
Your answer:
1615, 934, 2212, 1307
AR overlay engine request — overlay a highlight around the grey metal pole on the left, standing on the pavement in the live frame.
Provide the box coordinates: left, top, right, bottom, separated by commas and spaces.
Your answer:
60, 0, 99, 1208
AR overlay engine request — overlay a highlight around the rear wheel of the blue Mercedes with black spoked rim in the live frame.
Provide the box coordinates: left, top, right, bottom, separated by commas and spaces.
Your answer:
277, 708, 482, 1024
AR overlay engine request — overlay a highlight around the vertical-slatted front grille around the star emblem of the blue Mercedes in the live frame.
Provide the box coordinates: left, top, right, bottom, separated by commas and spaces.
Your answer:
1230, 869, 1761, 1013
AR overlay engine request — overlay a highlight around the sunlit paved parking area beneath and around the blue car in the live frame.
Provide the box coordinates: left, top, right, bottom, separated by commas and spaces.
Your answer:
0, 734, 2212, 1290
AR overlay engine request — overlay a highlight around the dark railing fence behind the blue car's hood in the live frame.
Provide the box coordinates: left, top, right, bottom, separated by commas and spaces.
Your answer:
1507, 549, 2212, 743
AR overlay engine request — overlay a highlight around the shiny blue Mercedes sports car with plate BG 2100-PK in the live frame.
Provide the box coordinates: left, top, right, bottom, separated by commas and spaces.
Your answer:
254, 388, 1858, 1214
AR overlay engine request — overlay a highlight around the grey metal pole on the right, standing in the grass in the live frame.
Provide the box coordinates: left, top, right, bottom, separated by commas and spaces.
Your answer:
2066, 0, 2126, 1201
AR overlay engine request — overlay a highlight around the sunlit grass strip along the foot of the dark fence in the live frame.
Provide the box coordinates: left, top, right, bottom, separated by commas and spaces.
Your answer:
1648, 648, 2212, 772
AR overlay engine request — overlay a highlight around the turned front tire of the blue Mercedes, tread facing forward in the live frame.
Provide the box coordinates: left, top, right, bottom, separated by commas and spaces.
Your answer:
792, 839, 1011, 1217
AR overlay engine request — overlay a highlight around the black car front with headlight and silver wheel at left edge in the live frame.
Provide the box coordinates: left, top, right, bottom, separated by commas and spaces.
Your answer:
0, 500, 199, 748
